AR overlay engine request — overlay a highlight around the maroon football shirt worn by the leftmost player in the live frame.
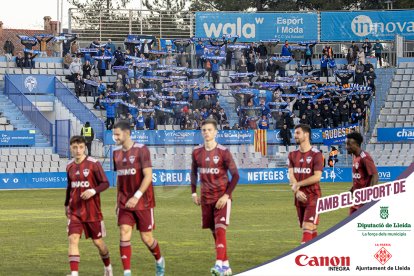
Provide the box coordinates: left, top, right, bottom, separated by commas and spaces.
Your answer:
65, 157, 109, 222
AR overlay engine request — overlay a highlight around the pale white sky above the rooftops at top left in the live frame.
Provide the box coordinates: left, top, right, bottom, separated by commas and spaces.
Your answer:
0, 0, 146, 30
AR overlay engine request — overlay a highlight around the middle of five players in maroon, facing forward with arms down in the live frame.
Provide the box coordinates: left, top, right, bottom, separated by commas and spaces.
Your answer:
191, 119, 239, 276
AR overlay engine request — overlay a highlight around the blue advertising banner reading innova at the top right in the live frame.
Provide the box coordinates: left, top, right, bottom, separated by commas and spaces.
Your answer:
321, 10, 414, 41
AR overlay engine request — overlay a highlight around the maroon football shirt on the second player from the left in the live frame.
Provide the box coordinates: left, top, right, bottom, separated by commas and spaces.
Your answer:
113, 143, 155, 210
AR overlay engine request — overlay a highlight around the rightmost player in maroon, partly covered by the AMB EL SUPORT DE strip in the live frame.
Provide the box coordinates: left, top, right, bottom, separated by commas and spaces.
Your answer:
346, 132, 378, 215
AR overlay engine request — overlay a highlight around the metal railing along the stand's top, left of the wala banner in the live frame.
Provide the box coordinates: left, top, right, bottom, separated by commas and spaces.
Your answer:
69, 9, 195, 43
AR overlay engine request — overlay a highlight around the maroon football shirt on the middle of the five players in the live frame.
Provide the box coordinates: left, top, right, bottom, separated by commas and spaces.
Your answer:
191, 144, 239, 204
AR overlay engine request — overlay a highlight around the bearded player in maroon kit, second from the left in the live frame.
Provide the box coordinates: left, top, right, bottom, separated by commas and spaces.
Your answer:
113, 121, 165, 276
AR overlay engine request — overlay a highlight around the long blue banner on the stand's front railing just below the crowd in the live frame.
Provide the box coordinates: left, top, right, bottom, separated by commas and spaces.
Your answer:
104, 129, 323, 146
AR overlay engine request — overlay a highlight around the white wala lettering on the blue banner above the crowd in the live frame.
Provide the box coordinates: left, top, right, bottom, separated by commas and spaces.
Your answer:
203, 17, 264, 38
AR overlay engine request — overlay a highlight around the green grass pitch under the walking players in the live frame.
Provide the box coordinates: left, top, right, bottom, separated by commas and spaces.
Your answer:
0, 183, 351, 276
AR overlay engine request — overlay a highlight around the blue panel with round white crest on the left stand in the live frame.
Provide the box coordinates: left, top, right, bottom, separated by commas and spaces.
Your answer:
9, 74, 55, 94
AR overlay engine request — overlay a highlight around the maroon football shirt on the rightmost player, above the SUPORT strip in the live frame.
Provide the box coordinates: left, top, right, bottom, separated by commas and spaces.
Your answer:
352, 151, 378, 191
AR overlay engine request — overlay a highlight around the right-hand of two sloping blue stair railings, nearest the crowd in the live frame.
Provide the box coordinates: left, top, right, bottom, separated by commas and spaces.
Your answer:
55, 78, 104, 141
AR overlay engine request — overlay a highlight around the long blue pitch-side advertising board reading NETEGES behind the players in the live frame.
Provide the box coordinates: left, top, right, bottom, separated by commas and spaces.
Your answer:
0, 167, 406, 190
